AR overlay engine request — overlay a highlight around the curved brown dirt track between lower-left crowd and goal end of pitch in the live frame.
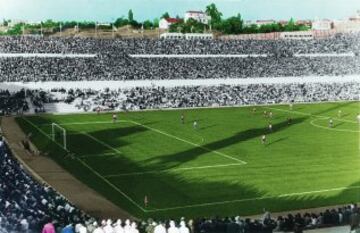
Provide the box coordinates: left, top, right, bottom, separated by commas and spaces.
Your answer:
1, 117, 132, 219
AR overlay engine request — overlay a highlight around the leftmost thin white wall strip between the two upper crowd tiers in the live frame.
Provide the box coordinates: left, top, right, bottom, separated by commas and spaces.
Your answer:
0, 53, 96, 58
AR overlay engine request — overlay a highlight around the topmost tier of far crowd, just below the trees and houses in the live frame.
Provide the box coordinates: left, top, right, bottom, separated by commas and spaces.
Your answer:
0, 33, 360, 54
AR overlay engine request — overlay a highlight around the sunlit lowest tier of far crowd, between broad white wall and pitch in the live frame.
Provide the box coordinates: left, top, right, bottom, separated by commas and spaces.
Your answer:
43, 83, 360, 111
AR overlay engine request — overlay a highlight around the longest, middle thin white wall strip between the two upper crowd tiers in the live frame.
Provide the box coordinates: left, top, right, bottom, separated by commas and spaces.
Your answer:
129, 54, 268, 58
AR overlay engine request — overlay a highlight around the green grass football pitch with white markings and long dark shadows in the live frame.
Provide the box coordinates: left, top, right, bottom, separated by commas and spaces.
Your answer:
17, 102, 360, 218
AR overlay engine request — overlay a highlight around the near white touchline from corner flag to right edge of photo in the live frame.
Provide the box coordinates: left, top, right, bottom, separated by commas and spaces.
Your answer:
145, 186, 360, 212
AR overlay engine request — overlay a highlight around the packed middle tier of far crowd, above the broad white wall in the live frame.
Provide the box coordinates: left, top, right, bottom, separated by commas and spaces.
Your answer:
4, 55, 360, 82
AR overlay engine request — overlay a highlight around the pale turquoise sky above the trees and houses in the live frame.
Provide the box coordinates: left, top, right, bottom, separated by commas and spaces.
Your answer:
0, 0, 360, 22
